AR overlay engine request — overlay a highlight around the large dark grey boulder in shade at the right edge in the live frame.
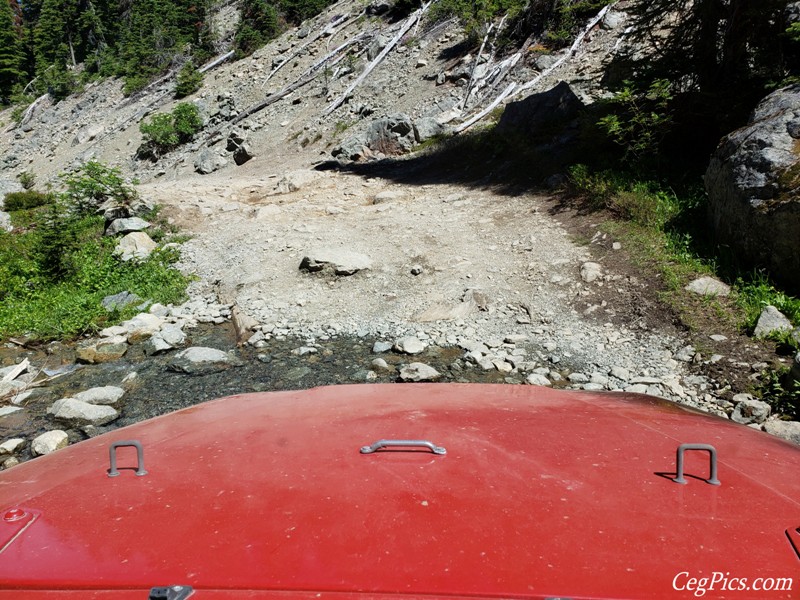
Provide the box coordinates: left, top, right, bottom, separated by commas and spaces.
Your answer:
705, 84, 800, 292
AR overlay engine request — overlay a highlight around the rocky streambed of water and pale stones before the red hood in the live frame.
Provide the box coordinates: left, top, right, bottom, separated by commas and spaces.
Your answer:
0, 302, 800, 468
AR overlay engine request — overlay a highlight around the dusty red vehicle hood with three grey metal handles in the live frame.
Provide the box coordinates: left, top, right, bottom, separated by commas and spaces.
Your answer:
0, 384, 800, 600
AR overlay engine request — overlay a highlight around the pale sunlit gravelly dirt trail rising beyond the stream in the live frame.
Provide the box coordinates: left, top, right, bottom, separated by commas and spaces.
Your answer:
141, 150, 681, 378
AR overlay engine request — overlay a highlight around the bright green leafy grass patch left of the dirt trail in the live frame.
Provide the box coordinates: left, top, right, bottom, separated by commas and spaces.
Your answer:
0, 164, 189, 341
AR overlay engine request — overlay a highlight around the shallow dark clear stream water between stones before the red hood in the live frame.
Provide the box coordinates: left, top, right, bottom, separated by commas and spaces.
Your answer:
0, 323, 523, 460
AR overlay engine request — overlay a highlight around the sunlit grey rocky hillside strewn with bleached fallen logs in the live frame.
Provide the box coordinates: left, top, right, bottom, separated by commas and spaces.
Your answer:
0, 1, 628, 189
